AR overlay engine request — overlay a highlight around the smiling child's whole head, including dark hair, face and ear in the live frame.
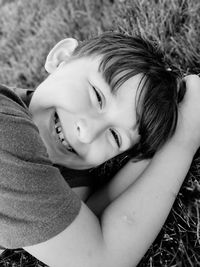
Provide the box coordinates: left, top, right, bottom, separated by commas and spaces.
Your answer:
30, 30, 181, 169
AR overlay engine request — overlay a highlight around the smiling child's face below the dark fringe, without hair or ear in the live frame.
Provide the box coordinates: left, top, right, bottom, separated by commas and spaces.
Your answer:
30, 57, 142, 169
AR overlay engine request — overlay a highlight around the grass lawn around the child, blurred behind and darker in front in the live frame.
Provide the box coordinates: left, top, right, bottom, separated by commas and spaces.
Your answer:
0, 0, 200, 267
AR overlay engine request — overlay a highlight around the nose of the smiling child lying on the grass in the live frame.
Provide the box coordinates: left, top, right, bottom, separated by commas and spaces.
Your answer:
76, 119, 108, 144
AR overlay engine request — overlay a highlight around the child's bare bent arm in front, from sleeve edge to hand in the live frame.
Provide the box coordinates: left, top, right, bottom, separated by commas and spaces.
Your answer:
25, 76, 200, 267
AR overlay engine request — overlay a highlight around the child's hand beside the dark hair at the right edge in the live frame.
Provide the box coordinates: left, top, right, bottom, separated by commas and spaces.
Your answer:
175, 75, 200, 153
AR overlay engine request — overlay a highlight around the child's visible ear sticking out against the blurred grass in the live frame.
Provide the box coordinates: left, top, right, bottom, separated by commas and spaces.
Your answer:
44, 38, 78, 73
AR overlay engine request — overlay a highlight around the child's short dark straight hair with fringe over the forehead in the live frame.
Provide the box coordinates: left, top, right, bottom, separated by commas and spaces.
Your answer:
73, 32, 183, 163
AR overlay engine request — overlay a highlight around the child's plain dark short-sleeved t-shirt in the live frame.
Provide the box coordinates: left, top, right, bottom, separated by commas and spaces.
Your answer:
0, 86, 81, 248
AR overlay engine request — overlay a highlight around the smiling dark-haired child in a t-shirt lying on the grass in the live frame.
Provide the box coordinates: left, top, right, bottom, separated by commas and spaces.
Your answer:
0, 31, 200, 267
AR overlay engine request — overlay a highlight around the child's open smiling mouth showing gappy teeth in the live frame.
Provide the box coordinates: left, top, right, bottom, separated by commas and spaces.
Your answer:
54, 112, 78, 154
